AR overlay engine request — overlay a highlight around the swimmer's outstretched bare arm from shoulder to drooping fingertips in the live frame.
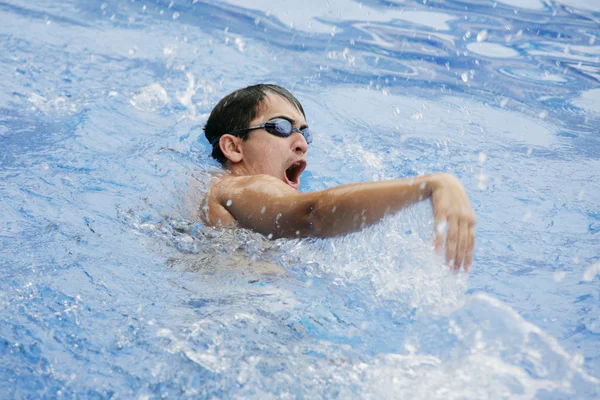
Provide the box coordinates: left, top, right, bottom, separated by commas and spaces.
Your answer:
211, 174, 475, 269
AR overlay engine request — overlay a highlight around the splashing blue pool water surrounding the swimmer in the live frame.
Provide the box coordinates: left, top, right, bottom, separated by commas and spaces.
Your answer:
0, 0, 600, 399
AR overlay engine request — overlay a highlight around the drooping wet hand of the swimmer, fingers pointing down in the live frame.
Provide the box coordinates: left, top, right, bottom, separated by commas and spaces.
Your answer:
431, 174, 475, 272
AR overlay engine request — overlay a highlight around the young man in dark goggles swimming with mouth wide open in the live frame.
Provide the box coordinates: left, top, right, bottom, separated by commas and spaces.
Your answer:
204, 84, 475, 271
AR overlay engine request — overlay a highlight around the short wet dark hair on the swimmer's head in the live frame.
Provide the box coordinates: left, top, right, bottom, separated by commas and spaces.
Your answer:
204, 83, 306, 164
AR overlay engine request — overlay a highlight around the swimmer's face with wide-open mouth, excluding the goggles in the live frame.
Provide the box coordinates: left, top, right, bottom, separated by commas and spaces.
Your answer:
240, 93, 308, 190
